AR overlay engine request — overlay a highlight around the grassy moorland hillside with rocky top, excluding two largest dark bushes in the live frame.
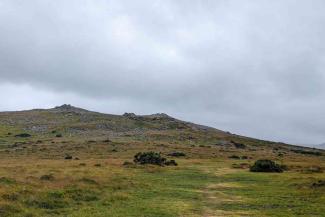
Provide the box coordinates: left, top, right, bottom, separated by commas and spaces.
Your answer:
0, 105, 325, 217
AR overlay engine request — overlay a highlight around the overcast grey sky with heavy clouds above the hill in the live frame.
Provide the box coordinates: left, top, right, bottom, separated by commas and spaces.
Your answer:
0, 0, 325, 144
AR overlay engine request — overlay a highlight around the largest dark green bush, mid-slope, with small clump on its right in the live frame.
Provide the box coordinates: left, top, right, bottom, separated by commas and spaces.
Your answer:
133, 152, 177, 166
